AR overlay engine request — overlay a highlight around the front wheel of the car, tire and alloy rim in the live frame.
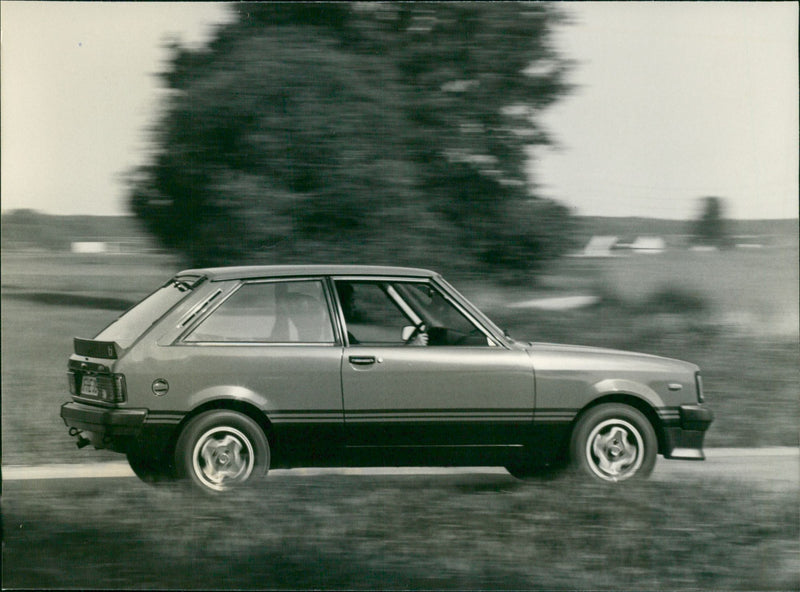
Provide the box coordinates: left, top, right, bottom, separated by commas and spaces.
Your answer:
570, 403, 658, 483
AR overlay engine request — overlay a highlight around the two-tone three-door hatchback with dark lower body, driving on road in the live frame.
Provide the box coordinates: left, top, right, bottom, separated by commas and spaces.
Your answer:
61, 265, 713, 494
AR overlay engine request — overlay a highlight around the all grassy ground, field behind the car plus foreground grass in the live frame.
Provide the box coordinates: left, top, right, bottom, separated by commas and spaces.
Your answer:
2, 244, 800, 590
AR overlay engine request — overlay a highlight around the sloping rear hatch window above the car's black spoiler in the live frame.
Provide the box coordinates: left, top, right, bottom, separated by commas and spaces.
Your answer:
95, 278, 199, 348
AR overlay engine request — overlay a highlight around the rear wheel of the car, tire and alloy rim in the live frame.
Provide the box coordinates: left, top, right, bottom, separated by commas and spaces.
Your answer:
175, 410, 270, 494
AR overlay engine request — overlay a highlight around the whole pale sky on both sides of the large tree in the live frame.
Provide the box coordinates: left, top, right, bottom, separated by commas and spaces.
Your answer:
0, 0, 800, 219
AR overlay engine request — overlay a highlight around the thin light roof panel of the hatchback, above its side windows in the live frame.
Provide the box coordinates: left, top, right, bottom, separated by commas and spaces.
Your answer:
176, 265, 438, 282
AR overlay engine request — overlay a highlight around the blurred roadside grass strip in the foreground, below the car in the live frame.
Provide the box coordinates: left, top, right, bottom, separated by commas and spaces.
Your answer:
2, 474, 800, 590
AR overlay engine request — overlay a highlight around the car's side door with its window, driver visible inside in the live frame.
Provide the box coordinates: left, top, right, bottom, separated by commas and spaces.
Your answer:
335, 278, 534, 447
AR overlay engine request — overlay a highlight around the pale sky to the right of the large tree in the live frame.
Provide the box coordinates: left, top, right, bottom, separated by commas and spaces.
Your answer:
533, 2, 800, 218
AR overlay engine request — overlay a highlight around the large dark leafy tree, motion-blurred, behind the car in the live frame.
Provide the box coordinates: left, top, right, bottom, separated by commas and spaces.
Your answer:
131, 3, 580, 280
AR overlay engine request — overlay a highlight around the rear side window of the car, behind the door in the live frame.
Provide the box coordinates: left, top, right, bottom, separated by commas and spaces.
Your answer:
184, 280, 334, 344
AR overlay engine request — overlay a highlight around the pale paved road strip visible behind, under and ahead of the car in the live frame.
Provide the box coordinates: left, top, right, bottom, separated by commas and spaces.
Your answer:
3, 448, 800, 490
